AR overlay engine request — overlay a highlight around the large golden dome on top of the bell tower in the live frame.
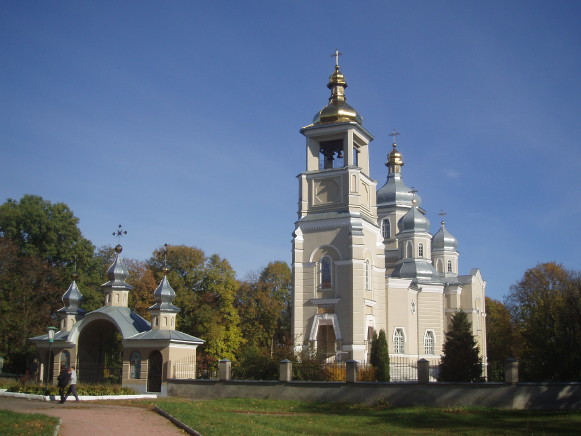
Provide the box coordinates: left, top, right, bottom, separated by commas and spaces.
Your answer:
313, 65, 363, 125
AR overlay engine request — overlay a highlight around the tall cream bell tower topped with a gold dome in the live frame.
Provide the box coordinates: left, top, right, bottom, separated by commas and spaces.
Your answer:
292, 51, 385, 361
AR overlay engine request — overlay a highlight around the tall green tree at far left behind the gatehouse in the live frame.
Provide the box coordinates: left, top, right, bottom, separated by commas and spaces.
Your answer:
0, 195, 95, 372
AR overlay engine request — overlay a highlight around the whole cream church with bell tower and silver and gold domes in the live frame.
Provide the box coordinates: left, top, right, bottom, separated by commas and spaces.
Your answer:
291, 56, 486, 369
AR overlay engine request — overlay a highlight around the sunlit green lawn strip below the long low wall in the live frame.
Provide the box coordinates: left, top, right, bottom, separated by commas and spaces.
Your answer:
155, 399, 581, 436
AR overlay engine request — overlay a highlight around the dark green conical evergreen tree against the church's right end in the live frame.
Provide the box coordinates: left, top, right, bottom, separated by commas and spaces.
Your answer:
438, 310, 482, 382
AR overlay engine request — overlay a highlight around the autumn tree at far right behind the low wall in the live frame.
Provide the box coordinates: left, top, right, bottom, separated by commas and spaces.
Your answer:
505, 263, 581, 381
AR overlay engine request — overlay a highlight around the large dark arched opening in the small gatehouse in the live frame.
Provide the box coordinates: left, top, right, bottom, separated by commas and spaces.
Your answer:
77, 319, 123, 383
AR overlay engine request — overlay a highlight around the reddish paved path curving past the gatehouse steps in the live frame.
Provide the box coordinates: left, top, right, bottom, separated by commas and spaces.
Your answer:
0, 397, 185, 436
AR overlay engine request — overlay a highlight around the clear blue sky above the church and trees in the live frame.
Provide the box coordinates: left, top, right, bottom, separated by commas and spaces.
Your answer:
0, 0, 581, 299
